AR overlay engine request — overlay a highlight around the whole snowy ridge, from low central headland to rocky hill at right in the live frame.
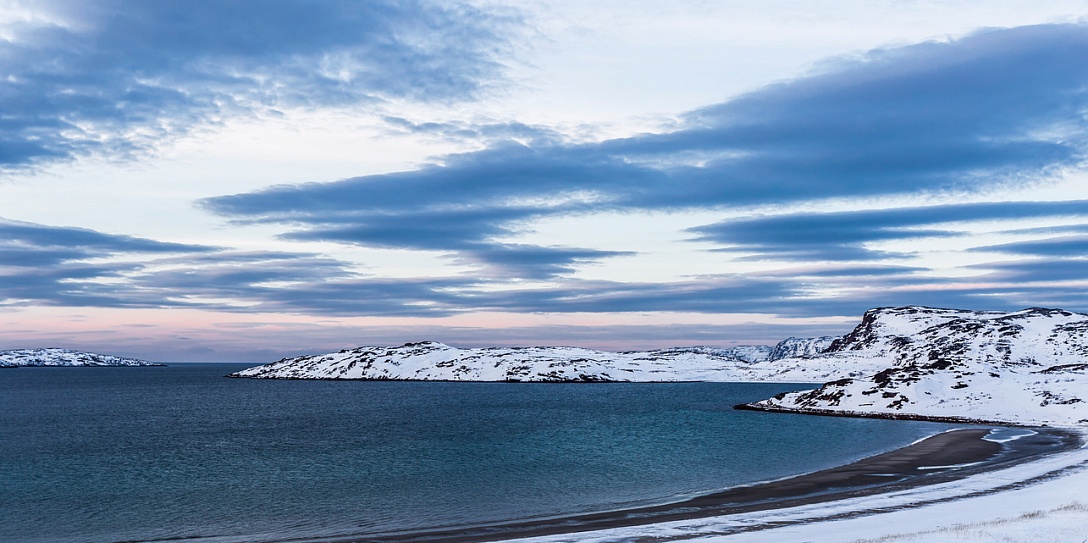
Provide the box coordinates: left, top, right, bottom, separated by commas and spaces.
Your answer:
230, 306, 1088, 424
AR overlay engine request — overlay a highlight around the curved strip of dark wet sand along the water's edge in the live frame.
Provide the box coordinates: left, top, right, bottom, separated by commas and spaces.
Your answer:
341, 428, 1080, 543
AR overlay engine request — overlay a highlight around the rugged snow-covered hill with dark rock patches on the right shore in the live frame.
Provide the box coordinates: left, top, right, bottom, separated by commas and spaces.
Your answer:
750, 307, 1088, 424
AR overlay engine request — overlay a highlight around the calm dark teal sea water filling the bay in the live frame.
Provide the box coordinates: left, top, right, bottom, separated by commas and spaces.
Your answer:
0, 365, 947, 543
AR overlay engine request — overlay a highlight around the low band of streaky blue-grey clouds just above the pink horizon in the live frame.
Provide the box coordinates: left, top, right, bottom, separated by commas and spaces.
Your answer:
0, 215, 1088, 318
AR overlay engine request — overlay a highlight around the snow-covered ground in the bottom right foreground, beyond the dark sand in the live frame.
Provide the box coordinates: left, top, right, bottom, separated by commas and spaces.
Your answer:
507, 428, 1088, 543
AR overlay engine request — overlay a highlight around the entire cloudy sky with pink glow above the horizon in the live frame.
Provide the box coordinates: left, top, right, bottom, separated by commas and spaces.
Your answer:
0, 0, 1088, 362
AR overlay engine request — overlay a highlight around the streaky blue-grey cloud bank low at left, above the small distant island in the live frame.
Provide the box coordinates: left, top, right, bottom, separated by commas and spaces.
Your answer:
0, 220, 411, 312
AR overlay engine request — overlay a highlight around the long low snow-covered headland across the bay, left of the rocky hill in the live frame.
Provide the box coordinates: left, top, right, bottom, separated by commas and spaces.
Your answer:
231, 337, 837, 382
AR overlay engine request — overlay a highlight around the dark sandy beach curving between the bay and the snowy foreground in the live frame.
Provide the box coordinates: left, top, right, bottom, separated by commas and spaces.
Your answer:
341, 428, 1083, 543
